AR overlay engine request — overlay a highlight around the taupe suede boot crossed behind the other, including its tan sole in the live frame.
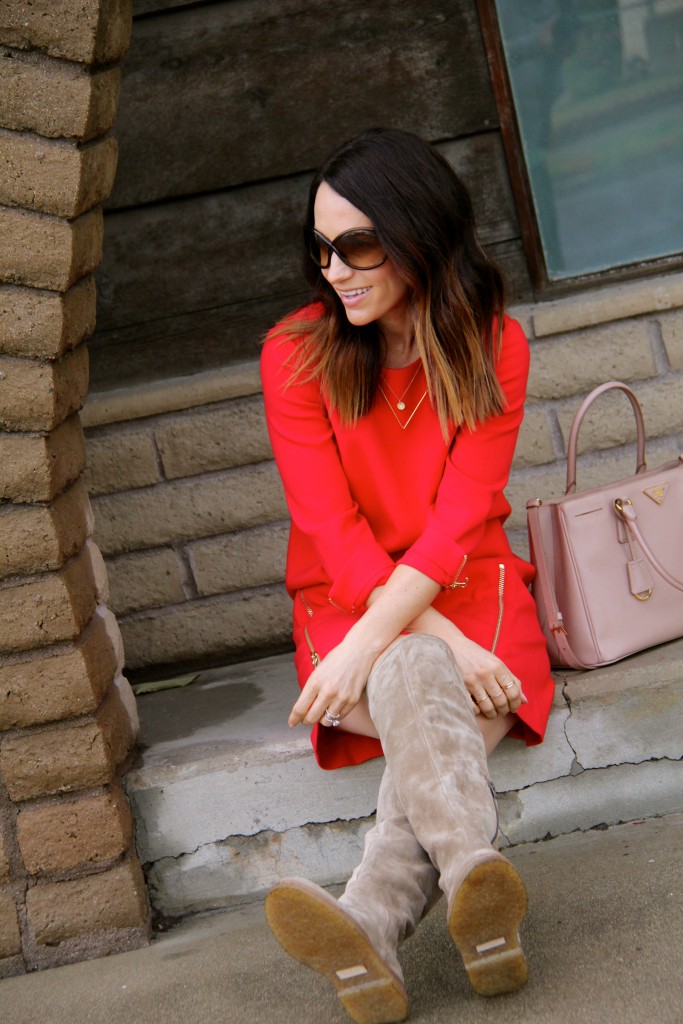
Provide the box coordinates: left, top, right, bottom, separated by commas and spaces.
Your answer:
265, 771, 439, 1024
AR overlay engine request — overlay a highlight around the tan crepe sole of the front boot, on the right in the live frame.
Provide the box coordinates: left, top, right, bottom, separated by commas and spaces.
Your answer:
449, 857, 527, 995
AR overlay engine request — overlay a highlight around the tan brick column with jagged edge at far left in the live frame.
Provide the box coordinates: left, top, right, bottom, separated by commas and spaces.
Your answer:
0, 0, 148, 977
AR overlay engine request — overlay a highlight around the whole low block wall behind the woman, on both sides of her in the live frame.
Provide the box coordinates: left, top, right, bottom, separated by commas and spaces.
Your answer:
84, 274, 683, 675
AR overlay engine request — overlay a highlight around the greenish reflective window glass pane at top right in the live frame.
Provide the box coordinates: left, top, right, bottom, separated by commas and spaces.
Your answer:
496, 0, 683, 280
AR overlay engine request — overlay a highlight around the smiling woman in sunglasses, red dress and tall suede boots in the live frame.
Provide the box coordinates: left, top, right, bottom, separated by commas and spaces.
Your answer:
262, 129, 553, 1024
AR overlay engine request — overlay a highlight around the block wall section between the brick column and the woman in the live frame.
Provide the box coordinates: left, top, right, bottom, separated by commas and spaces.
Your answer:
84, 364, 289, 675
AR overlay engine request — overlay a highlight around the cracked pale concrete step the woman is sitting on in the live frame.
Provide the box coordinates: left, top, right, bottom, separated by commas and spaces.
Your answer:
126, 640, 683, 916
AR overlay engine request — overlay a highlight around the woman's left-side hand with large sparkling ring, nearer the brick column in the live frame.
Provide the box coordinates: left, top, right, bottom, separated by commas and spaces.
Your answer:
288, 633, 379, 726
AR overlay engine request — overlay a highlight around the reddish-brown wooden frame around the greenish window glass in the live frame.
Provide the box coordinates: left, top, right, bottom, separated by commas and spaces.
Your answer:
475, 0, 683, 299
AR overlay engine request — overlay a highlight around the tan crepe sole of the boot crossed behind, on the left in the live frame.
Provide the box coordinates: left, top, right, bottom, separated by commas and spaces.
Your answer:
265, 879, 409, 1024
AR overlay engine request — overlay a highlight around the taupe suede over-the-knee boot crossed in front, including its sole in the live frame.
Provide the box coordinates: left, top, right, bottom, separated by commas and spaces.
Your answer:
368, 634, 526, 995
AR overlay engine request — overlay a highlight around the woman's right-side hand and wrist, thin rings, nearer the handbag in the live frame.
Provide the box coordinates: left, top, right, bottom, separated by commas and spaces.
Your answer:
409, 608, 527, 718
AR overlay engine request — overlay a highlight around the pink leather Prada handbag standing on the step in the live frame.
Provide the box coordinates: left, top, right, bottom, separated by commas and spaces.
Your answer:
526, 381, 683, 670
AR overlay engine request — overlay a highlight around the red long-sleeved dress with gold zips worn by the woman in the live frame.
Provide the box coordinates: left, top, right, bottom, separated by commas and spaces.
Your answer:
261, 308, 553, 768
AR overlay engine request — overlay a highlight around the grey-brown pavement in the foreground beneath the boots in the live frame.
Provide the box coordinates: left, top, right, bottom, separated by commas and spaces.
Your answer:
5, 814, 683, 1024
